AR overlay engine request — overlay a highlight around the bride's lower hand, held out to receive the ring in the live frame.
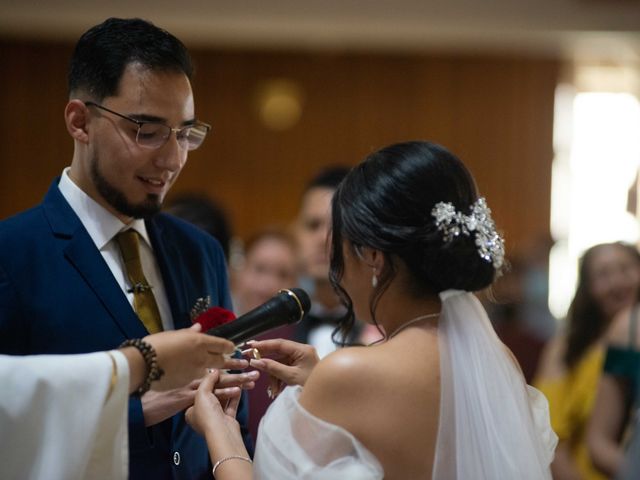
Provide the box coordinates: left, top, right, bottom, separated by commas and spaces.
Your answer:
185, 370, 241, 437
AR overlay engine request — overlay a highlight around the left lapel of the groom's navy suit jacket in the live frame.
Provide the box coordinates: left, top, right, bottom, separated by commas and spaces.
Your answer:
43, 179, 147, 338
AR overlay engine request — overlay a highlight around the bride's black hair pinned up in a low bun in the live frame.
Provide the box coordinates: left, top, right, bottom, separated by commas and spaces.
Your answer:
332, 142, 500, 293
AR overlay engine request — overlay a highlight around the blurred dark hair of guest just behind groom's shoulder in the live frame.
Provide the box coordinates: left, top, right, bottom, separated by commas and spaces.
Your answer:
165, 193, 232, 262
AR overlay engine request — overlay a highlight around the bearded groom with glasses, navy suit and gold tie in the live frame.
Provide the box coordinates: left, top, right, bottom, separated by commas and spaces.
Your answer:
0, 19, 252, 479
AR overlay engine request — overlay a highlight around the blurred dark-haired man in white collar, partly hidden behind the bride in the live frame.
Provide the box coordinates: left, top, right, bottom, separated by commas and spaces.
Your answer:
295, 166, 359, 358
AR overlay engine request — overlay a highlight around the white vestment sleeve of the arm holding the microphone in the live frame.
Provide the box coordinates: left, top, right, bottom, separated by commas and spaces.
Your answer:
0, 351, 129, 480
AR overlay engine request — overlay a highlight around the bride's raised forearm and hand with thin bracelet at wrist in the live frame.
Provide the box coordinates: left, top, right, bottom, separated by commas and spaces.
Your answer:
185, 371, 253, 480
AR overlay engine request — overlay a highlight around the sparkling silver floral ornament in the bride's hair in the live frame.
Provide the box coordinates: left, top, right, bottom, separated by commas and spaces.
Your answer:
431, 197, 504, 270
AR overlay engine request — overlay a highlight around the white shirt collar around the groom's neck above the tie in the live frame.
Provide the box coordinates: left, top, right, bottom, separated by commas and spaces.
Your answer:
58, 167, 151, 250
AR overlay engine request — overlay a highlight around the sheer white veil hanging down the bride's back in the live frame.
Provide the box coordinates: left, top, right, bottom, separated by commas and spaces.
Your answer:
433, 290, 557, 480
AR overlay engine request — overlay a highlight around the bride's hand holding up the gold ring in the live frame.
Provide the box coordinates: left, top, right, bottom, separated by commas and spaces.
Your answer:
245, 339, 320, 397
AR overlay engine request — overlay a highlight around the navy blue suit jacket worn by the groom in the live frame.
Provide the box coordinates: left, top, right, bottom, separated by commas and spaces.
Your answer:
0, 179, 250, 479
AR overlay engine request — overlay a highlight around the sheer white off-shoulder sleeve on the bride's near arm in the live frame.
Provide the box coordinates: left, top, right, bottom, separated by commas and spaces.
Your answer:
254, 387, 384, 480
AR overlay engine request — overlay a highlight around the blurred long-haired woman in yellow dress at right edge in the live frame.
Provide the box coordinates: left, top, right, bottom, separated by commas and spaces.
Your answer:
536, 243, 640, 479
